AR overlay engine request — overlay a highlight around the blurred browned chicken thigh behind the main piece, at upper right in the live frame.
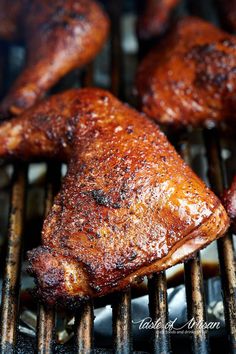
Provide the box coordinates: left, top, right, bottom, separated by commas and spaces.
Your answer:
136, 17, 236, 127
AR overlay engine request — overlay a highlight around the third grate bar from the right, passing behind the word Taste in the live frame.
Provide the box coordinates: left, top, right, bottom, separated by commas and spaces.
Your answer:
148, 272, 170, 353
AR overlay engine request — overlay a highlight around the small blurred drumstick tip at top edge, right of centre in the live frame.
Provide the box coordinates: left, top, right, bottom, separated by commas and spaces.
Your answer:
137, 0, 180, 40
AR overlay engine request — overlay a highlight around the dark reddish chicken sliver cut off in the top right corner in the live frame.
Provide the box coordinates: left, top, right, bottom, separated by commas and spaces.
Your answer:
215, 0, 236, 32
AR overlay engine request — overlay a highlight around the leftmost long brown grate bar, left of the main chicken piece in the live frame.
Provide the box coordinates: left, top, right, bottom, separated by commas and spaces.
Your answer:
0, 165, 27, 354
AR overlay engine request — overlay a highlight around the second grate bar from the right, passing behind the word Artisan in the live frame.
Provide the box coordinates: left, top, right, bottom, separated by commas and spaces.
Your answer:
180, 132, 208, 354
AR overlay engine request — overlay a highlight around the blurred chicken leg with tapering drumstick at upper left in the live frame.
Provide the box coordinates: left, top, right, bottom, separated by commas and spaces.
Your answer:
0, 0, 109, 117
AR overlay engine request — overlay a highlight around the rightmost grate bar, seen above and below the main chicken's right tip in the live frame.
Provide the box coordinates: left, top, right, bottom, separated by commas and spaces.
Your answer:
204, 128, 236, 353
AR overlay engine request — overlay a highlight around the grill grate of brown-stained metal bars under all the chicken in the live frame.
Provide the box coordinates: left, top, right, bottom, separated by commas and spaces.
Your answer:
0, 0, 236, 354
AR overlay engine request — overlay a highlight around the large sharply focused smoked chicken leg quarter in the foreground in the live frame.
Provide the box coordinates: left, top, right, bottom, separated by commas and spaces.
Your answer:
0, 88, 229, 306
